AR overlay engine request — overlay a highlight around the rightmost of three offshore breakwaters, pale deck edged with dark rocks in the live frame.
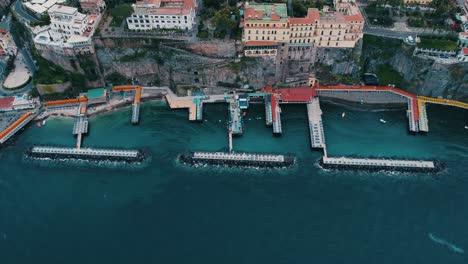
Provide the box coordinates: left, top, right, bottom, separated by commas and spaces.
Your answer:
321, 155, 441, 172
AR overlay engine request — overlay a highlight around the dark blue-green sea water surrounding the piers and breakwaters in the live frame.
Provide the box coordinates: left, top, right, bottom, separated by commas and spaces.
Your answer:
0, 104, 468, 264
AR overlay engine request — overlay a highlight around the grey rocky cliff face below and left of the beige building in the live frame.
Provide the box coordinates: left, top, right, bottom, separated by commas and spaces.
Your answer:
97, 44, 275, 88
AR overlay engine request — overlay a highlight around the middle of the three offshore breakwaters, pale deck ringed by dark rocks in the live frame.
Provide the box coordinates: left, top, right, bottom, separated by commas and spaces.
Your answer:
179, 152, 295, 168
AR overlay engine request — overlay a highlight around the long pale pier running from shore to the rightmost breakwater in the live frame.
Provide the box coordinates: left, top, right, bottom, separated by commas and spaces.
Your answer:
307, 97, 326, 151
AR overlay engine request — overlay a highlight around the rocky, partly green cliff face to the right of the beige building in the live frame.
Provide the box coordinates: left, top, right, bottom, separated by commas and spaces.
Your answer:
315, 36, 468, 101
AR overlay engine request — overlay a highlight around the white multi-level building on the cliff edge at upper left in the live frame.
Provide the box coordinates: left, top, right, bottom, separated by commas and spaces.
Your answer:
34, 5, 100, 56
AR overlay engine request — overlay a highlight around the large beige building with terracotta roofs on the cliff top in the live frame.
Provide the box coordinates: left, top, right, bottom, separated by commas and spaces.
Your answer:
242, 2, 364, 56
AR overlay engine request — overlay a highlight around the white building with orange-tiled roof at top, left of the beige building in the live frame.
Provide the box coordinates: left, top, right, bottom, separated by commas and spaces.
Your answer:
127, 0, 196, 30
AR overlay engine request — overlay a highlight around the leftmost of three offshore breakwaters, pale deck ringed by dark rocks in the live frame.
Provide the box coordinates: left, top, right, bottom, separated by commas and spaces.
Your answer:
27, 146, 144, 162
